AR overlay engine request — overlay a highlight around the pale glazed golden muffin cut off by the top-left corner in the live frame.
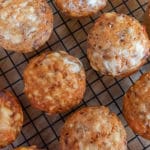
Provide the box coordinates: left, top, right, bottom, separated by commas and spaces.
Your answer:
0, 0, 53, 53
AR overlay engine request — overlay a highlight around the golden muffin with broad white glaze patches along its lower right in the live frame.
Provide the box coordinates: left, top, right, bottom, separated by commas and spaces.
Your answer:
87, 12, 150, 77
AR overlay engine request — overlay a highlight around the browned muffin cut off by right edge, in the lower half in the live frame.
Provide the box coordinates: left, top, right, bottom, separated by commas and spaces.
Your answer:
123, 72, 150, 140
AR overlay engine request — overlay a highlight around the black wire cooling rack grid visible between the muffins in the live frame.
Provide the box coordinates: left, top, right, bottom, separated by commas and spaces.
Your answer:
0, 0, 150, 150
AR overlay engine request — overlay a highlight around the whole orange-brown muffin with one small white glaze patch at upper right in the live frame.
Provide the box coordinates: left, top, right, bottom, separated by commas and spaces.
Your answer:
24, 51, 86, 114
